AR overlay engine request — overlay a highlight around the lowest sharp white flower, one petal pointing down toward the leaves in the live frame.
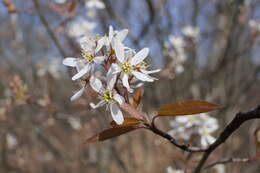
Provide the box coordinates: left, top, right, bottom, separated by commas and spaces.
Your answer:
90, 71, 124, 124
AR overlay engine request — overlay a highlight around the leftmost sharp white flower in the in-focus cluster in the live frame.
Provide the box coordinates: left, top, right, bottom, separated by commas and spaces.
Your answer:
63, 37, 105, 80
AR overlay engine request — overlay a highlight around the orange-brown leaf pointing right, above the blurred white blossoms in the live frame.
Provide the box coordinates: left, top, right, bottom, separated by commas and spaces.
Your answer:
158, 100, 221, 116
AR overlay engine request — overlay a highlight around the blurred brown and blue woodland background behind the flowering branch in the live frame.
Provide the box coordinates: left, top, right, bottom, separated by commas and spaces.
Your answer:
0, 0, 260, 173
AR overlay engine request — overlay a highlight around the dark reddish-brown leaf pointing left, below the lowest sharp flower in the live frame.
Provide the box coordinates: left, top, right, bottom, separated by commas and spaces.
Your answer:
86, 126, 138, 143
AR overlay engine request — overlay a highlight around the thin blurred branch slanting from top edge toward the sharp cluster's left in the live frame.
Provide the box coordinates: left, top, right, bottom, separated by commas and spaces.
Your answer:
32, 0, 66, 58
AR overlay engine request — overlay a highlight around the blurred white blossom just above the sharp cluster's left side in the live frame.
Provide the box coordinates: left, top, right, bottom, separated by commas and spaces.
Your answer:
66, 18, 96, 38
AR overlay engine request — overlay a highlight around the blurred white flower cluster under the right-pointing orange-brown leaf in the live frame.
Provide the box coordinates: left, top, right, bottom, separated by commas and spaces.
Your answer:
169, 113, 219, 147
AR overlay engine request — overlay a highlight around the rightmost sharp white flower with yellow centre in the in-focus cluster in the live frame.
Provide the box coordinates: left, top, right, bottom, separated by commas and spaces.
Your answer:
111, 40, 160, 92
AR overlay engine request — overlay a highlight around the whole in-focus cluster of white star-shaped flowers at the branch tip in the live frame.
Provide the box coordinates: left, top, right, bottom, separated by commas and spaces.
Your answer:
63, 26, 160, 124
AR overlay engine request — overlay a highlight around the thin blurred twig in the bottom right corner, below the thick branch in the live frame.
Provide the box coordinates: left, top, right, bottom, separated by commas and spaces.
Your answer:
205, 157, 259, 169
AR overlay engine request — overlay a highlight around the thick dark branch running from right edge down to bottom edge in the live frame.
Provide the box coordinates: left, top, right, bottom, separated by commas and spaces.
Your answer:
194, 105, 260, 173
